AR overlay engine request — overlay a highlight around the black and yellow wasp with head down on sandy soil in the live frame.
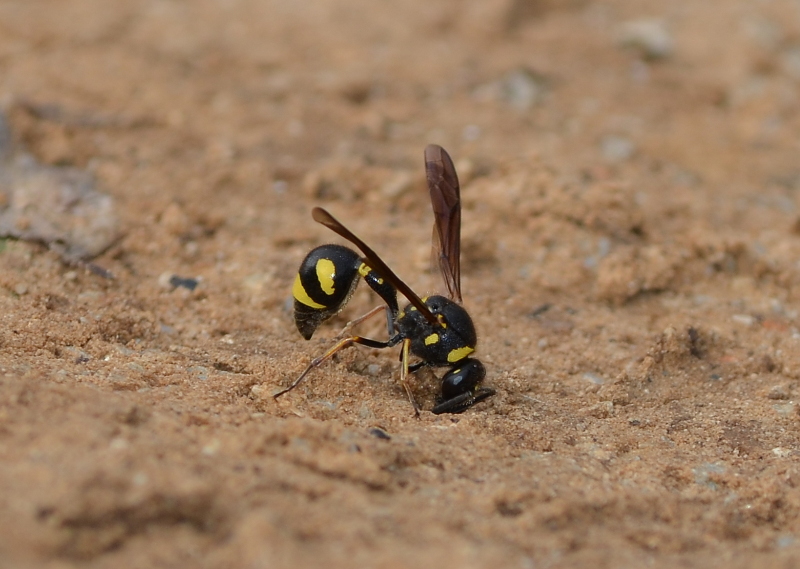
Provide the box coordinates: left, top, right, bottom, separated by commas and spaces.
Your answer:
274, 144, 495, 416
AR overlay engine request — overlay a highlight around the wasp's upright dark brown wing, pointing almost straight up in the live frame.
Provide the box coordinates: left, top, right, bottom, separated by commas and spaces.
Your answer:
425, 144, 462, 303
